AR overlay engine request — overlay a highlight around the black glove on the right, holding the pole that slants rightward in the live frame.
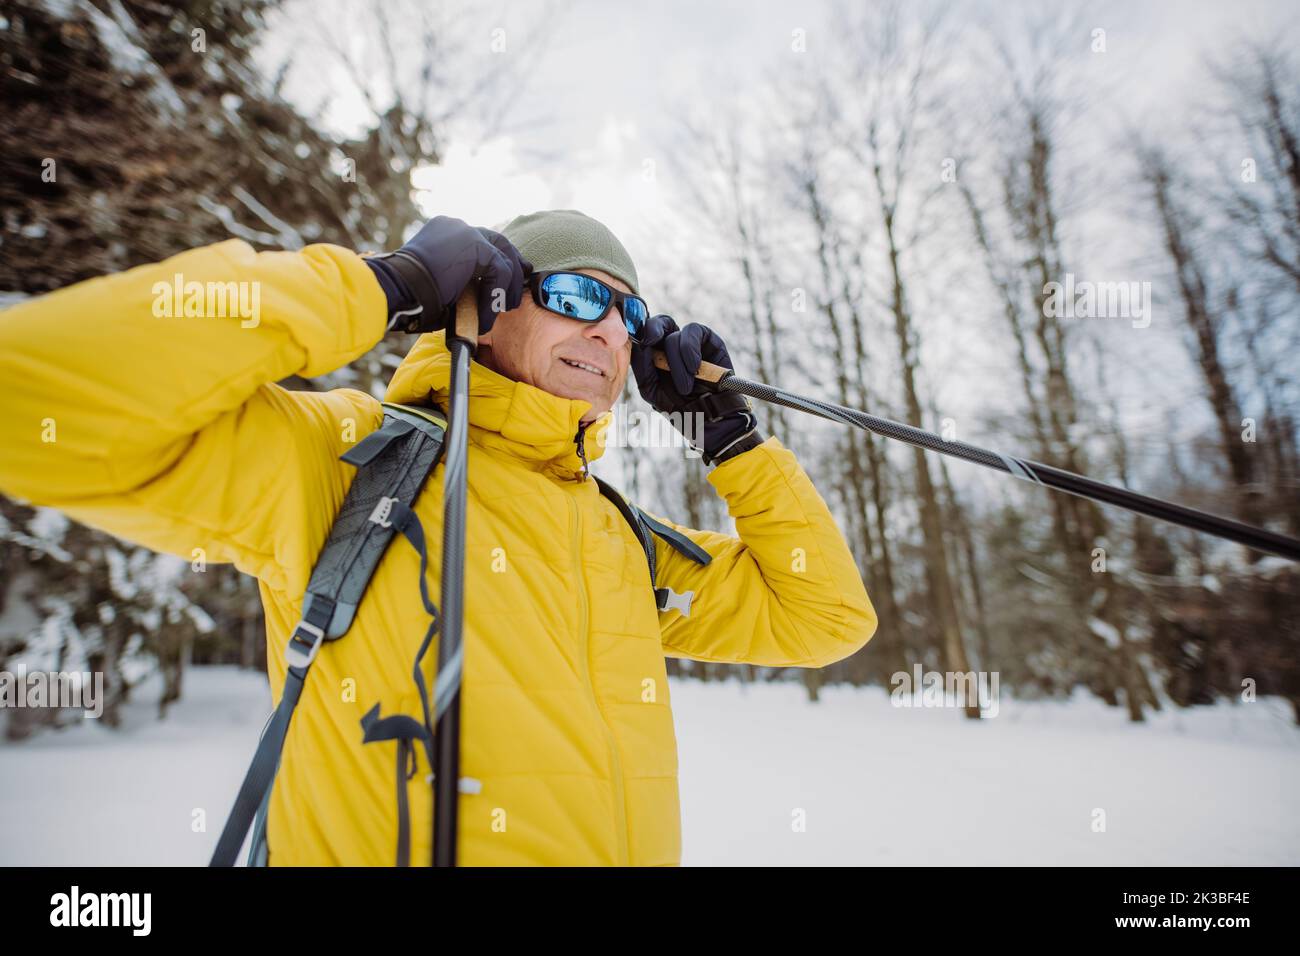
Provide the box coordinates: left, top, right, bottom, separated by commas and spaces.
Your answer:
632, 315, 763, 464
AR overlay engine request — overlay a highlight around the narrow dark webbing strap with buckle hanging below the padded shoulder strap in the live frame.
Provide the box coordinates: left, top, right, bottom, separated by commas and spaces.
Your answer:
209, 594, 334, 866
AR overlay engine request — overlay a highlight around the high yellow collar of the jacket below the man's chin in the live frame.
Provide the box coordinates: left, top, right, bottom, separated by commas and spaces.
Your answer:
384, 332, 614, 481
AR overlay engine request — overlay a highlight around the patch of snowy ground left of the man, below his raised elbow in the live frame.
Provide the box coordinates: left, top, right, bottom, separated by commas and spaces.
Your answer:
0, 667, 270, 866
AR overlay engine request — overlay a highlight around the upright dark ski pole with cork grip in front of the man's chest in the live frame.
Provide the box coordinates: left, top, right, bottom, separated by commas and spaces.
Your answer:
433, 289, 478, 866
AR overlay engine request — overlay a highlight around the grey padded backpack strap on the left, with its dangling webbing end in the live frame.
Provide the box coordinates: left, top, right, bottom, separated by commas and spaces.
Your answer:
211, 403, 447, 866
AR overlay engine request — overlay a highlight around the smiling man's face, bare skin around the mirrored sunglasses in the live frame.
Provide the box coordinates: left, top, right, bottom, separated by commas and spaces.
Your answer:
477, 269, 632, 421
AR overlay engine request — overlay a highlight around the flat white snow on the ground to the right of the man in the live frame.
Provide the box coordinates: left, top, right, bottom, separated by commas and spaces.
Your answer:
672, 683, 1300, 866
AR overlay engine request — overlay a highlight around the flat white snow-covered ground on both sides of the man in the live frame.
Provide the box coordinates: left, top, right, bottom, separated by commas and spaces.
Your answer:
0, 667, 1300, 865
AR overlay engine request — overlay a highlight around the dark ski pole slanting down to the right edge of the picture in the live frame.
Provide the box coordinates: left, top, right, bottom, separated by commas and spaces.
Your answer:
654, 350, 1300, 561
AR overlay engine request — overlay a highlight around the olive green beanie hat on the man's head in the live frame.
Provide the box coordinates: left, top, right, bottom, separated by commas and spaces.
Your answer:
501, 209, 641, 295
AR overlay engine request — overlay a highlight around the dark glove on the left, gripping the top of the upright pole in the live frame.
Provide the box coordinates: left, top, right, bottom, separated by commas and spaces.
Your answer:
363, 216, 533, 336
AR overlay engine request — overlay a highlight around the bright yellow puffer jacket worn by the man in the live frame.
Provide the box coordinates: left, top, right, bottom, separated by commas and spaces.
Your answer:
0, 241, 876, 865
